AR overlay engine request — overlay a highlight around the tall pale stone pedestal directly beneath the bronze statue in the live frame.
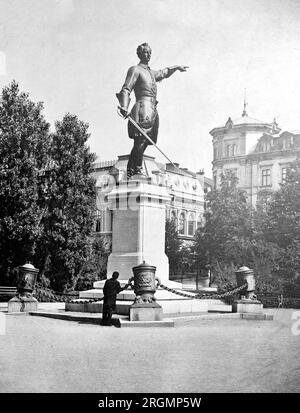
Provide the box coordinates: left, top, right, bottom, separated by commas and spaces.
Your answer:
107, 177, 171, 284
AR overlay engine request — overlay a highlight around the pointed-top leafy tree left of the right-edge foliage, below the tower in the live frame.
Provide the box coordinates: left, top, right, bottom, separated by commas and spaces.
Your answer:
195, 169, 281, 288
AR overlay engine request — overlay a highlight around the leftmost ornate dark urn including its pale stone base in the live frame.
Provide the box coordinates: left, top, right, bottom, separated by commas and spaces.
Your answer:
8, 263, 39, 313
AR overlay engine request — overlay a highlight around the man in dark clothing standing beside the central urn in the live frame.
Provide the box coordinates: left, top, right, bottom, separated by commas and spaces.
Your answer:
102, 271, 128, 325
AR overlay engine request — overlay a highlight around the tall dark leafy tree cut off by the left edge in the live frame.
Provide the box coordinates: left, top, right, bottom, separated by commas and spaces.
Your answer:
0, 81, 50, 283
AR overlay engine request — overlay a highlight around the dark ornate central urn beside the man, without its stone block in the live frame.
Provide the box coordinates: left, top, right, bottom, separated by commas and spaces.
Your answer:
129, 261, 160, 303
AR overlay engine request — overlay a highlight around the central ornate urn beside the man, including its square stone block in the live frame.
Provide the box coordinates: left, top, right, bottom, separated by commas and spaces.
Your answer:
128, 261, 162, 321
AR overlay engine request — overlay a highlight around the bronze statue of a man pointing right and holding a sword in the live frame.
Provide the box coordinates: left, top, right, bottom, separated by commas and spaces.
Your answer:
116, 43, 188, 179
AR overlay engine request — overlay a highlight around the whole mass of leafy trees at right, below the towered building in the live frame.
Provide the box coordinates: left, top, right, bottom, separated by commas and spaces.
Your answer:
195, 166, 300, 297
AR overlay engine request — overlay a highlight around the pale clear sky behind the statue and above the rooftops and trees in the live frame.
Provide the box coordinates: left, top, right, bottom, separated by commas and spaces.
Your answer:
0, 0, 300, 177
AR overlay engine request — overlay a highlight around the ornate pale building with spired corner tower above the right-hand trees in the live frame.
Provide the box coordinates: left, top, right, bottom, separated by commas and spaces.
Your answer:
210, 103, 300, 207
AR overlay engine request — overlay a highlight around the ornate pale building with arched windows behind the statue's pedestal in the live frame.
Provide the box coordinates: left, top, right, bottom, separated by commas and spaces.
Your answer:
94, 155, 212, 241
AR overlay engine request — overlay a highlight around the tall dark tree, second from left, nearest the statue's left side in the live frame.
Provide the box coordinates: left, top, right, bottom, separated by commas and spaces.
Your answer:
35, 114, 96, 291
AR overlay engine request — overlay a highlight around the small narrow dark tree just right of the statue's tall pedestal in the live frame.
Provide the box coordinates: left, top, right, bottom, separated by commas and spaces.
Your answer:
165, 219, 182, 274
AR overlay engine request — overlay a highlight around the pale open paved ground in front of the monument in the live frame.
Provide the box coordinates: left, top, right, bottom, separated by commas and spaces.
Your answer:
0, 309, 300, 393
